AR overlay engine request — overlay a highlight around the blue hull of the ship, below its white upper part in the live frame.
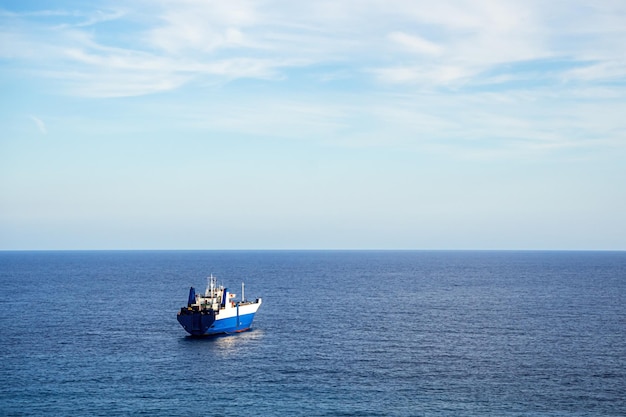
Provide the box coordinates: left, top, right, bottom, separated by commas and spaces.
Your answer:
177, 312, 255, 336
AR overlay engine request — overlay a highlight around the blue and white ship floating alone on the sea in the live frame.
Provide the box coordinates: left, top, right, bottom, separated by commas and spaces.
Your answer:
177, 274, 262, 336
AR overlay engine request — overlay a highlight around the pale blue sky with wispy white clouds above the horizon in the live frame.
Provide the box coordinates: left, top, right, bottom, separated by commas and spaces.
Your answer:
0, 0, 626, 250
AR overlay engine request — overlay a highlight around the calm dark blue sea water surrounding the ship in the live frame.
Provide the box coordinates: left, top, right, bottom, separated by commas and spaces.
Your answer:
0, 251, 626, 416
